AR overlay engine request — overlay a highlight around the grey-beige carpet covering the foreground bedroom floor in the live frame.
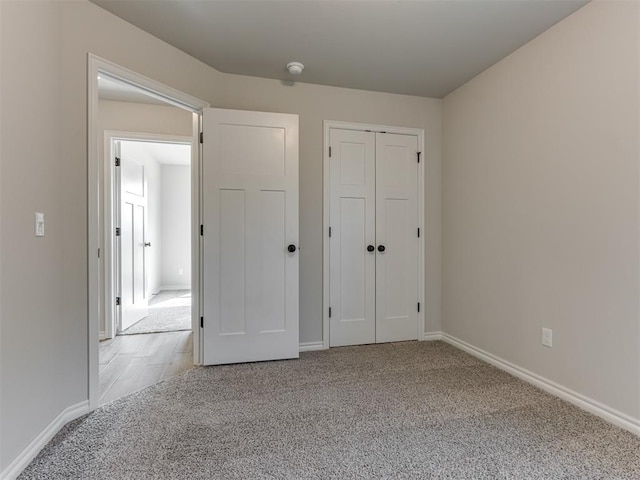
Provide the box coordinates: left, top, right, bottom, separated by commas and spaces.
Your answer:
20, 342, 640, 480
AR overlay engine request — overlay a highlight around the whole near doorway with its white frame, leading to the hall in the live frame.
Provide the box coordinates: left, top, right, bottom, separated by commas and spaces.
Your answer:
88, 54, 208, 410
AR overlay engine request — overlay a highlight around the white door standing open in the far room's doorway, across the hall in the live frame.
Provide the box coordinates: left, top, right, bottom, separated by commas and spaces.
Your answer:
116, 142, 149, 331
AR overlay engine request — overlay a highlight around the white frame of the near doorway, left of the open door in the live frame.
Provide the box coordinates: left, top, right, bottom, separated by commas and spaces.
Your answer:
87, 53, 209, 410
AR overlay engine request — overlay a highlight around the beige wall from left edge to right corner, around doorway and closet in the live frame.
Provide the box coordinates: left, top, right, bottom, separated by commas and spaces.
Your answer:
0, 0, 441, 471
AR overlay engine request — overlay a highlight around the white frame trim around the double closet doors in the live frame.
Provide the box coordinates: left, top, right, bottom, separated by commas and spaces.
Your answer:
322, 120, 426, 348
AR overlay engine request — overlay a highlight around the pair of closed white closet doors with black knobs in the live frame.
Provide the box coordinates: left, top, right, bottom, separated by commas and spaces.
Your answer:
329, 128, 420, 347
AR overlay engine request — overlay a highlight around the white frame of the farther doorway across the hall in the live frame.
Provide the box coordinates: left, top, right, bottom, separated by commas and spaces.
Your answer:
100, 130, 193, 340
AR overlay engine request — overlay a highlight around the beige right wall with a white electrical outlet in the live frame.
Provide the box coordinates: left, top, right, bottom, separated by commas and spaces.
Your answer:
442, 1, 640, 418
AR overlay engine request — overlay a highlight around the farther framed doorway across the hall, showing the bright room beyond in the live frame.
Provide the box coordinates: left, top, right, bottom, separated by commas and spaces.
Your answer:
110, 137, 192, 335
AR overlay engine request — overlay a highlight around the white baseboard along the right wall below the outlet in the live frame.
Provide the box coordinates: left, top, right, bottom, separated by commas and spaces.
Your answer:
442, 333, 640, 436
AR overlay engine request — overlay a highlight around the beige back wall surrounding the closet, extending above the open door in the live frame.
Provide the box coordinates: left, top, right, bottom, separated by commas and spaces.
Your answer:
212, 75, 441, 342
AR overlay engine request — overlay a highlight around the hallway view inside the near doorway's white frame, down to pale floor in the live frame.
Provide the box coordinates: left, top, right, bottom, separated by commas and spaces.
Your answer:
98, 111, 193, 404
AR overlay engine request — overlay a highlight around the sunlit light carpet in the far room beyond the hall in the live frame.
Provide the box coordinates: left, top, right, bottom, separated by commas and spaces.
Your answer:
120, 290, 191, 335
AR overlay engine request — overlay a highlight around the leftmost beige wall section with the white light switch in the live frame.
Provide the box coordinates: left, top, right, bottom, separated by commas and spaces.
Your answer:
0, 2, 67, 471
